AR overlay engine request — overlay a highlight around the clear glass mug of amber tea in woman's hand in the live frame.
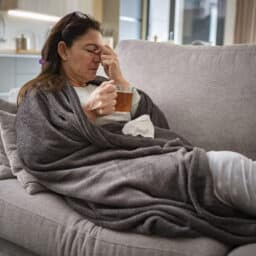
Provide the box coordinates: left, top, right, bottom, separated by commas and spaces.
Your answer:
115, 90, 133, 112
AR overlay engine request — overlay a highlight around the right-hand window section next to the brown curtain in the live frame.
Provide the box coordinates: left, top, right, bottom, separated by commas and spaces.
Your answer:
178, 0, 226, 45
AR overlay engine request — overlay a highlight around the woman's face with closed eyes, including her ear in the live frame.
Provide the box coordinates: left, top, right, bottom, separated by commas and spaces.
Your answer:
61, 29, 103, 86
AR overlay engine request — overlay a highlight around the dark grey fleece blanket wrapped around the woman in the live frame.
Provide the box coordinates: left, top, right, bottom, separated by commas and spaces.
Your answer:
16, 81, 256, 245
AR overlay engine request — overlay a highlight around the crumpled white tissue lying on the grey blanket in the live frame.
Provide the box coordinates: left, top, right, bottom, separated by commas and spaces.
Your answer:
122, 115, 155, 138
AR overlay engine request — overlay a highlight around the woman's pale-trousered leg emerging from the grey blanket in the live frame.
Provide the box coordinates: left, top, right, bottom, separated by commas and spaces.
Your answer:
207, 151, 256, 216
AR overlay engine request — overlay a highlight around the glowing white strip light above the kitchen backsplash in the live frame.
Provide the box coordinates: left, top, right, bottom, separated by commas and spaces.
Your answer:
8, 10, 60, 22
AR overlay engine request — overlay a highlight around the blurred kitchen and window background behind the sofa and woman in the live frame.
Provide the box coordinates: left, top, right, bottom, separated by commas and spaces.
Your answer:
0, 0, 256, 98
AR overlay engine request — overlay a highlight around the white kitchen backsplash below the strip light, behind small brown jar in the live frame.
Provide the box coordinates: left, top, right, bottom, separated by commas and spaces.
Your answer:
0, 11, 54, 51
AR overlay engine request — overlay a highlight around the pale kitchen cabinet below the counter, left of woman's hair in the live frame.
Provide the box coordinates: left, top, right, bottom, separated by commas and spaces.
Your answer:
0, 54, 41, 98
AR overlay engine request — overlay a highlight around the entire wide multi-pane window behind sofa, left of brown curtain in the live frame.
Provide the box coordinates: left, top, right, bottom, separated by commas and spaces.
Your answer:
116, 0, 227, 45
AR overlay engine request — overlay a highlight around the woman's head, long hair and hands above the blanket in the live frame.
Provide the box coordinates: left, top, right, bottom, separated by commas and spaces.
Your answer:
19, 12, 139, 125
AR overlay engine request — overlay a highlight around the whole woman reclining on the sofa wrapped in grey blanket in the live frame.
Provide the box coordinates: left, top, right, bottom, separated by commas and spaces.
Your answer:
16, 12, 256, 245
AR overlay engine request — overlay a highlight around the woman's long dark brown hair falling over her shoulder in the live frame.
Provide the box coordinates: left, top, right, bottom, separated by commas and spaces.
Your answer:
17, 12, 101, 104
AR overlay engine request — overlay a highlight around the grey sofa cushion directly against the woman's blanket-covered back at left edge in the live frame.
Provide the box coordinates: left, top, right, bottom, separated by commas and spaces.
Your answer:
0, 110, 46, 194
